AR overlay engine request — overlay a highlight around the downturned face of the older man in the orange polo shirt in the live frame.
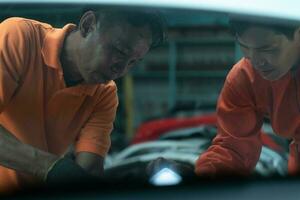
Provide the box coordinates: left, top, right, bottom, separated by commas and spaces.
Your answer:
78, 19, 152, 84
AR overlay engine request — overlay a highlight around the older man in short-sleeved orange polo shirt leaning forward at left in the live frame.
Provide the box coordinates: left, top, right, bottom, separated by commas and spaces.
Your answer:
0, 9, 164, 191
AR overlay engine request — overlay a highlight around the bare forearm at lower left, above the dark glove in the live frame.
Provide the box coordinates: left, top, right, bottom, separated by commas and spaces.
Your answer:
0, 126, 58, 178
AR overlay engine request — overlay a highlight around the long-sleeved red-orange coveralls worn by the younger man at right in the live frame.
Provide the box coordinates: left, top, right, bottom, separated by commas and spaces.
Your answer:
195, 58, 300, 175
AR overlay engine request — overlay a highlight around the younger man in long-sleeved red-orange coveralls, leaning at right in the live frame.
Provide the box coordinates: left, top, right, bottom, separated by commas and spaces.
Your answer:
195, 19, 300, 176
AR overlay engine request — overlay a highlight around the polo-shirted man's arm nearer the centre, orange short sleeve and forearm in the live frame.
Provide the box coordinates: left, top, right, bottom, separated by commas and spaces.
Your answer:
75, 81, 118, 176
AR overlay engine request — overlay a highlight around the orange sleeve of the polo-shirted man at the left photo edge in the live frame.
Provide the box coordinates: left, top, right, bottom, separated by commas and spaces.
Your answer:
0, 18, 31, 113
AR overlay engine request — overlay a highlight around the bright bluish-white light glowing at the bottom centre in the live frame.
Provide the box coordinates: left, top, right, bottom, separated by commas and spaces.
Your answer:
150, 168, 182, 186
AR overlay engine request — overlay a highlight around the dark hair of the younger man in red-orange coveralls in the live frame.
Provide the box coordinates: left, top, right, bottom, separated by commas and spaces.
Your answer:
229, 16, 300, 39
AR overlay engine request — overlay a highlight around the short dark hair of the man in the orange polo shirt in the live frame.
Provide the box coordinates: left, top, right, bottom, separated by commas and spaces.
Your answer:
84, 7, 167, 49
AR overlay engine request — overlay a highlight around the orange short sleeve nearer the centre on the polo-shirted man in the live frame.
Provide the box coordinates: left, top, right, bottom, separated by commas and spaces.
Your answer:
75, 83, 118, 157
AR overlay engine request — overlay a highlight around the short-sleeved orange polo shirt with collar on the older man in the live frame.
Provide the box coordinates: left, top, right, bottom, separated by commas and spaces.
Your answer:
0, 17, 118, 191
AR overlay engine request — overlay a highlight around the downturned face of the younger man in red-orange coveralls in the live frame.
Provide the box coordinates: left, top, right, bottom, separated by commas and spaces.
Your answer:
237, 27, 300, 81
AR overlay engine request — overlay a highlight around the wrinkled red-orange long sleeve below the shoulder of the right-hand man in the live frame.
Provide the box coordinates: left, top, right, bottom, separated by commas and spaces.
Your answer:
195, 74, 263, 176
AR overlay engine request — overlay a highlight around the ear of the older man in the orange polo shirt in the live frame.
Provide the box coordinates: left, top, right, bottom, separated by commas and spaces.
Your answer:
79, 11, 97, 37
